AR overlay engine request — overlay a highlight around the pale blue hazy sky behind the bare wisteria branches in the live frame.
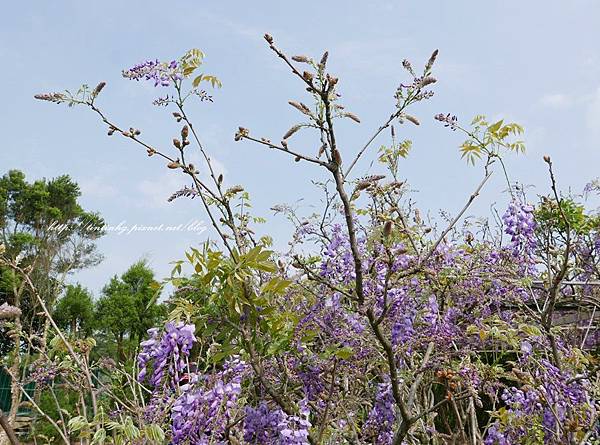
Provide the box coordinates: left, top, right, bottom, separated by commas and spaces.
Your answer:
0, 0, 600, 293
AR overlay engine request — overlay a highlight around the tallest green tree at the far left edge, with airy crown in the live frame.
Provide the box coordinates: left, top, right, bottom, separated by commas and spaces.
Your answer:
0, 170, 103, 430
